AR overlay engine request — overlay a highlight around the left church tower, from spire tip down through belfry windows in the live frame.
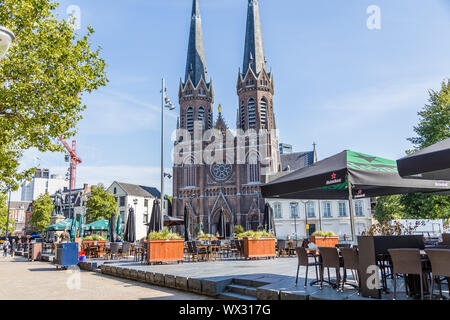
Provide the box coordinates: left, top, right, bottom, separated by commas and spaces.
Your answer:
178, 0, 214, 133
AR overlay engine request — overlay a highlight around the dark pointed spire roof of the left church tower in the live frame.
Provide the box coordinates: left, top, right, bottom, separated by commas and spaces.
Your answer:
185, 0, 207, 87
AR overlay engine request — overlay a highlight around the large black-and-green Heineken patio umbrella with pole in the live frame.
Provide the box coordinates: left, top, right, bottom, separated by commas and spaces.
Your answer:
261, 150, 450, 239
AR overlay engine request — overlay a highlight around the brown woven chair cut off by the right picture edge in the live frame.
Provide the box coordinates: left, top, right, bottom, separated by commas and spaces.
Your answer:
425, 249, 450, 300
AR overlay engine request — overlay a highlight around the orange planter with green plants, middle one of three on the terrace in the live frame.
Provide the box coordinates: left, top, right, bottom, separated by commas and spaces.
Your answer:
236, 231, 276, 259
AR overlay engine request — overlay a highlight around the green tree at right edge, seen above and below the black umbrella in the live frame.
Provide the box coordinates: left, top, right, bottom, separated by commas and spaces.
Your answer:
400, 80, 450, 219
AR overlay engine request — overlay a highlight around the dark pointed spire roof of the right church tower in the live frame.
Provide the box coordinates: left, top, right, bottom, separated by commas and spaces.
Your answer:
242, 0, 266, 75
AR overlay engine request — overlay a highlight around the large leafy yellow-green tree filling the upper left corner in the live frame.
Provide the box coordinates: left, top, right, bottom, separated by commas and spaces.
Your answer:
0, 0, 108, 192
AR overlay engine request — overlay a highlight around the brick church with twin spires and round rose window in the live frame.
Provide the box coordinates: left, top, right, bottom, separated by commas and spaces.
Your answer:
172, 0, 316, 237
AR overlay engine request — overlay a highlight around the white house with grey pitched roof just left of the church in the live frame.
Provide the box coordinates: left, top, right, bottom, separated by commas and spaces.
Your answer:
107, 181, 161, 240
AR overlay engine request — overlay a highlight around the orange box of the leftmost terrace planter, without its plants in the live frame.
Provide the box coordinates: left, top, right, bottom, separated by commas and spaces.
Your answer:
147, 239, 184, 263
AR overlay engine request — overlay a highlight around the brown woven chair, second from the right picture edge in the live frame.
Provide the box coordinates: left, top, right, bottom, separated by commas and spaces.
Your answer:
388, 249, 427, 300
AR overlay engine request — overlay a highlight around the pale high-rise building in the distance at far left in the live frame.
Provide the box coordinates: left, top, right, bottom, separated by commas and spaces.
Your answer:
21, 169, 69, 201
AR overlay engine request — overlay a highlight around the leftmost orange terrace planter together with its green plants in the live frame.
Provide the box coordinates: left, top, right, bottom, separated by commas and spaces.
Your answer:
147, 228, 184, 263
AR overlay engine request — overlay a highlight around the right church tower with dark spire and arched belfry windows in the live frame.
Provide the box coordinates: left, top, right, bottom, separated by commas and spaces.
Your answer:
236, 0, 281, 183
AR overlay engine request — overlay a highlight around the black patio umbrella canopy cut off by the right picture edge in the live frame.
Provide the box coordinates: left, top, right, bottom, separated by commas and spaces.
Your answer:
397, 138, 450, 180
